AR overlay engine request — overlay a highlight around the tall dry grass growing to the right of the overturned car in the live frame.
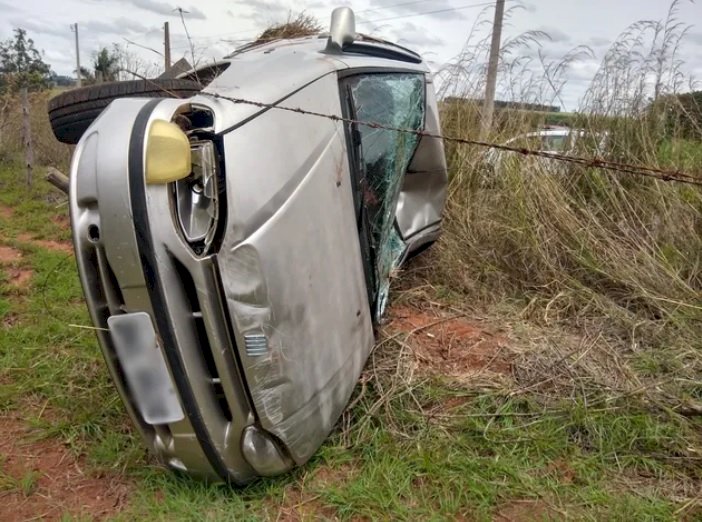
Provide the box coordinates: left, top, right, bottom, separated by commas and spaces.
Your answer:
429, 2, 702, 399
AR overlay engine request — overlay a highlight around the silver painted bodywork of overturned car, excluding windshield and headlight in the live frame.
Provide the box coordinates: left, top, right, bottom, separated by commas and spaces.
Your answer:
70, 32, 446, 483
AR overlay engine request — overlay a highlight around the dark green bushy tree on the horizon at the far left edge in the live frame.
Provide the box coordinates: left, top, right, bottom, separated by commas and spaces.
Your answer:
0, 28, 51, 92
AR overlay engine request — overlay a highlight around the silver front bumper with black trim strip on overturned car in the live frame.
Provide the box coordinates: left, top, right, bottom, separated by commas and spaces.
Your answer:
70, 99, 293, 484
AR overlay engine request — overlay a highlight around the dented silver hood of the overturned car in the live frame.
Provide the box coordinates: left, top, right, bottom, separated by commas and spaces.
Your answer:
219, 75, 373, 462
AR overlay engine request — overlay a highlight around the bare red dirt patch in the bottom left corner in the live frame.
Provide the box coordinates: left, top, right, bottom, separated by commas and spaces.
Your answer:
0, 417, 130, 522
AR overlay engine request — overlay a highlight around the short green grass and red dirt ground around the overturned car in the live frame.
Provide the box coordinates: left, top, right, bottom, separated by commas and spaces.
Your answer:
0, 146, 702, 520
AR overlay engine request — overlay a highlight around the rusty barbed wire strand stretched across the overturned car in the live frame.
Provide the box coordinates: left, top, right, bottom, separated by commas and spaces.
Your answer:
200, 91, 702, 186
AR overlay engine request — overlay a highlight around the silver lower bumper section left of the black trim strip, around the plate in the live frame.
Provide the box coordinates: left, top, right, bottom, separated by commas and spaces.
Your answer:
70, 99, 234, 476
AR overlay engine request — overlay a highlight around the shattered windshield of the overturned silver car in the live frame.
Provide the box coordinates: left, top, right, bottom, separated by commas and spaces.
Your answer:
344, 73, 425, 314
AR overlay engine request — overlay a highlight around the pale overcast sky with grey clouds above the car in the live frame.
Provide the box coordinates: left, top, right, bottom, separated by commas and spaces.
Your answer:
0, 0, 702, 109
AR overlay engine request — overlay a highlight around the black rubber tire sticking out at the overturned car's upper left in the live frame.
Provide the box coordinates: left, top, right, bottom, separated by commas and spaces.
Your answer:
48, 78, 202, 145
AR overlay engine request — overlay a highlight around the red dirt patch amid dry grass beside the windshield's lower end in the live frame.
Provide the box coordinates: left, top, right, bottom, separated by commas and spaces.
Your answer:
388, 307, 514, 377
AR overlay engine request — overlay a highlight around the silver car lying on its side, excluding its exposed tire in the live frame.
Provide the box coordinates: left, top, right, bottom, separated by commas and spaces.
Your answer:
54, 9, 446, 484
